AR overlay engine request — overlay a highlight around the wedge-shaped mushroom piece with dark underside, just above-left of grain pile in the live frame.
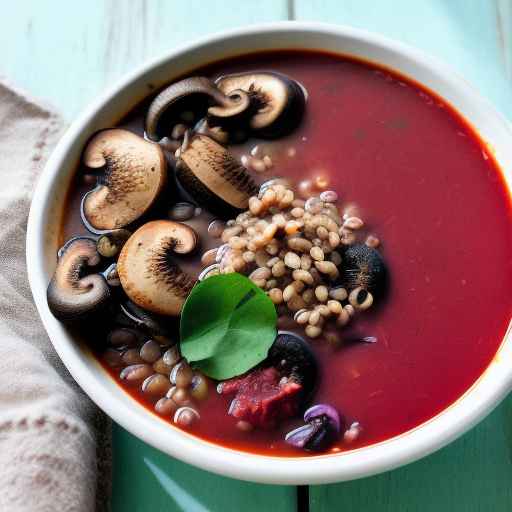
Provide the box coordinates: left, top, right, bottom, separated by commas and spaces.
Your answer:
176, 135, 258, 217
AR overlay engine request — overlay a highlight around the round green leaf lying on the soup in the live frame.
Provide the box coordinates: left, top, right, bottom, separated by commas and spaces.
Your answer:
180, 273, 277, 380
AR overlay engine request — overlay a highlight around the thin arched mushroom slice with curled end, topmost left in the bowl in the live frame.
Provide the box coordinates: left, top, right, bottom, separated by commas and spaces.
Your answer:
146, 76, 251, 142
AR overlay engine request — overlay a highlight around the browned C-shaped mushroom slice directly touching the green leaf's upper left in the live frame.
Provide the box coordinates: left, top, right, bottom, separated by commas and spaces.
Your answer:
117, 220, 197, 316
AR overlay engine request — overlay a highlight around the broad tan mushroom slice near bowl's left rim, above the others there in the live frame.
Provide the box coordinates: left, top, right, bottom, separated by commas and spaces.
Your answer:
82, 129, 167, 232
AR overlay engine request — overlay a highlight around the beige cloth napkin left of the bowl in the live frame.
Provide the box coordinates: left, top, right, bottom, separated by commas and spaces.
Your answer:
0, 82, 110, 512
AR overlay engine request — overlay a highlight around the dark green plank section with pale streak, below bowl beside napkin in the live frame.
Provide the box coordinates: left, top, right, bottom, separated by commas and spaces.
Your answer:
112, 427, 296, 512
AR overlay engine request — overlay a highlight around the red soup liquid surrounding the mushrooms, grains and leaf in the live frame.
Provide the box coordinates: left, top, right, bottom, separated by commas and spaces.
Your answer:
55, 51, 512, 456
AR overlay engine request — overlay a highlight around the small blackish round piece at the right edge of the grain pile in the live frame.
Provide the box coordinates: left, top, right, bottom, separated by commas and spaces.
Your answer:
341, 244, 387, 294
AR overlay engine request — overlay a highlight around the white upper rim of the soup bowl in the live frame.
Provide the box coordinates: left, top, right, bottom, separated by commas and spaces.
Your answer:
26, 21, 512, 485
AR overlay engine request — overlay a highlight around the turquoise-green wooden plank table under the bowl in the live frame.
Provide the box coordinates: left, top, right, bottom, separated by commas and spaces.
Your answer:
5, 0, 512, 512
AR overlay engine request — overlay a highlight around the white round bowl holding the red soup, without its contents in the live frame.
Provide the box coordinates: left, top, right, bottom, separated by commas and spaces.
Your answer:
27, 22, 512, 484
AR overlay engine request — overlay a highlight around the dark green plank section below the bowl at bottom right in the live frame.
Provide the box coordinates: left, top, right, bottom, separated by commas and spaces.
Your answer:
309, 399, 512, 512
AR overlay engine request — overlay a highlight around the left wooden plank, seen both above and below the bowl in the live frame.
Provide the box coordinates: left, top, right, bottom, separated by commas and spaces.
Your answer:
0, 0, 296, 512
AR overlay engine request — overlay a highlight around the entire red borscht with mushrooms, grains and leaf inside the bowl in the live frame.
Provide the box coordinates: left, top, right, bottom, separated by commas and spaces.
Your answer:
47, 51, 512, 457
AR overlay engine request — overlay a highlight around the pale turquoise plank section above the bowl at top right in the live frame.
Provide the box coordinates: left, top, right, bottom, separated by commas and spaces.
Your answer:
294, 0, 512, 119
